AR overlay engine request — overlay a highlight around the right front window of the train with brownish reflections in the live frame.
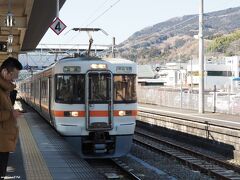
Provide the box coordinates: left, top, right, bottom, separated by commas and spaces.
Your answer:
114, 75, 137, 102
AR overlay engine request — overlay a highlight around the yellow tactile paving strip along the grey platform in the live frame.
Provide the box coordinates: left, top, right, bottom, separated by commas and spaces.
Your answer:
18, 115, 53, 180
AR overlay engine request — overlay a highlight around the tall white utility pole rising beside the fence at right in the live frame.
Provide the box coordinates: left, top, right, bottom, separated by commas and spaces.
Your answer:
198, 0, 204, 114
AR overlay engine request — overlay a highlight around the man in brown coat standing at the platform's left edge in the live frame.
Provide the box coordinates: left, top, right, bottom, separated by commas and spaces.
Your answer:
0, 57, 22, 179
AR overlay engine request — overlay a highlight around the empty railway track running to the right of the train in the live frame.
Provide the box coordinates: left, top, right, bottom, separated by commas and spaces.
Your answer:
134, 128, 240, 179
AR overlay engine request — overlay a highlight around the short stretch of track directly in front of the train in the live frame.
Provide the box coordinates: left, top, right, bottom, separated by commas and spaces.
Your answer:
87, 158, 140, 180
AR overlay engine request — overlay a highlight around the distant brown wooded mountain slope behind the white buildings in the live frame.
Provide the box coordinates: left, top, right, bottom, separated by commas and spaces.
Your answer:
117, 7, 240, 64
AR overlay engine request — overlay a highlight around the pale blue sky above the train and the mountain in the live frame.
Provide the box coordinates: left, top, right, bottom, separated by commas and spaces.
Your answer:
40, 0, 240, 44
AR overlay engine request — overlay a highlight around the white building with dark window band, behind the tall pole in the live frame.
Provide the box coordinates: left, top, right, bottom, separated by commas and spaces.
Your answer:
187, 56, 240, 91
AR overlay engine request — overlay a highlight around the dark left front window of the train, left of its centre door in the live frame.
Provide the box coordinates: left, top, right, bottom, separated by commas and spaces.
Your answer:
56, 74, 85, 104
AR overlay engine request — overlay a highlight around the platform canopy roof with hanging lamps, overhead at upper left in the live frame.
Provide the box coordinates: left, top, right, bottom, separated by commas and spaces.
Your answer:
0, 0, 66, 64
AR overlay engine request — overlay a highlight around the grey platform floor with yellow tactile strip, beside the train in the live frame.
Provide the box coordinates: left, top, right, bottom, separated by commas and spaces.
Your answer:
6, 101, 104, 180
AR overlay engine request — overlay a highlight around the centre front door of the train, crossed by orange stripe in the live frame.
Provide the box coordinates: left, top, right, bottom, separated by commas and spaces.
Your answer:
85, 71, 113, 131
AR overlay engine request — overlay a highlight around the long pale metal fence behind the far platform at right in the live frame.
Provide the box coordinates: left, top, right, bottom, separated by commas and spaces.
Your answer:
137, 86, 240, 115
